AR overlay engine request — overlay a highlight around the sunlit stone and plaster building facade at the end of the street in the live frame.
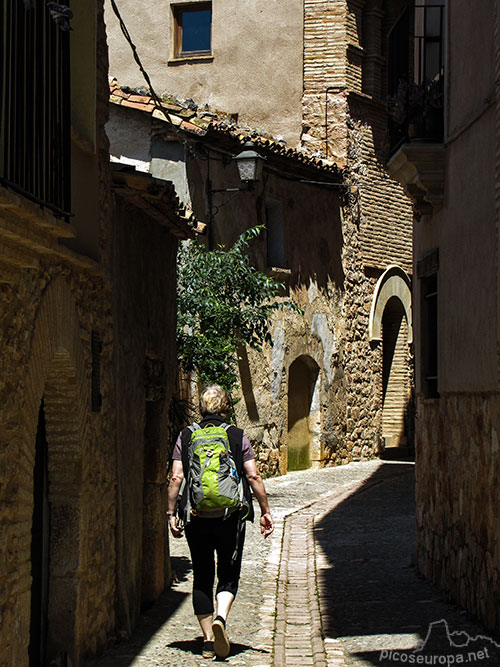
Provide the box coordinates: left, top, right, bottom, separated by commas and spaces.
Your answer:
106, 0, 413, 473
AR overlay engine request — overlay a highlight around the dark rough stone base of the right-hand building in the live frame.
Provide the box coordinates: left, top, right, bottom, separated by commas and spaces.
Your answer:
416, 395, 500, 632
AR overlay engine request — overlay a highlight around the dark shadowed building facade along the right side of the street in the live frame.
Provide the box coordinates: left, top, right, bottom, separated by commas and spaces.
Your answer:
389, 1, 500, 632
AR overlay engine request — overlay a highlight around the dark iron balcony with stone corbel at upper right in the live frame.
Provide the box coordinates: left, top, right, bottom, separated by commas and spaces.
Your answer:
387, 0, 445, 215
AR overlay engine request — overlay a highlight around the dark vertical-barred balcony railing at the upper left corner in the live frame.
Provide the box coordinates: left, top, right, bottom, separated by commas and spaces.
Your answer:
0, 0, 71, 218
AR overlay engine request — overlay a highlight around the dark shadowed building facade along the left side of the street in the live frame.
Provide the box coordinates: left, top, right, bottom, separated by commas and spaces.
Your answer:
0, 0, 189, 667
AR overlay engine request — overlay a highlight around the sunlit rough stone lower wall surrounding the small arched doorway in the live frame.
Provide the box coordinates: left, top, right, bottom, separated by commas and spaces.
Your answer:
232, 193, 388, 475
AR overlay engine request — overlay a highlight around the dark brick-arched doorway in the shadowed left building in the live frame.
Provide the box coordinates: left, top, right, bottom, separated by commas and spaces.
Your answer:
22, 279, 89, 667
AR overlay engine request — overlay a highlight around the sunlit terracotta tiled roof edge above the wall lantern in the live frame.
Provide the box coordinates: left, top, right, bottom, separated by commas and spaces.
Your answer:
110, 79, 343, 181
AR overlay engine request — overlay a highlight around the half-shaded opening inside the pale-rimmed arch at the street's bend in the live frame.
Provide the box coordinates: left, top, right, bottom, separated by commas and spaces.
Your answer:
382, 296, 409, 447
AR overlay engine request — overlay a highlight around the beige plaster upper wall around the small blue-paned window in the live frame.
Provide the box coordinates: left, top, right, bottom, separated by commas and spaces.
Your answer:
106, 0, 303, 145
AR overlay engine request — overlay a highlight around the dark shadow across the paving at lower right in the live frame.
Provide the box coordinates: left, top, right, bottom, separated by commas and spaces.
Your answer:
315, 463, 500, 667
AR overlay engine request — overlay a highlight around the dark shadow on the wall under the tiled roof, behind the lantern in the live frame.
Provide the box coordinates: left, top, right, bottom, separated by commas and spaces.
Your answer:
186, 153, 345, 290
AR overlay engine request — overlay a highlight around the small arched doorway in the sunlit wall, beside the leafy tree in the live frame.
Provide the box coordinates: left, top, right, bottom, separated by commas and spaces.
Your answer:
288, 356, 319, 470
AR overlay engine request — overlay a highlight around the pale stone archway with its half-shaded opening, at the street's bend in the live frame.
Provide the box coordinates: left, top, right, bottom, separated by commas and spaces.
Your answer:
369, 266, 412, 447
